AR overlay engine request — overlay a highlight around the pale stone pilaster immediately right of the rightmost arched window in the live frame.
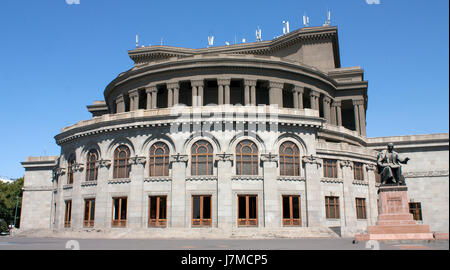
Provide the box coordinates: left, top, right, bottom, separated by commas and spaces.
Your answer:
302, 155, 325, 227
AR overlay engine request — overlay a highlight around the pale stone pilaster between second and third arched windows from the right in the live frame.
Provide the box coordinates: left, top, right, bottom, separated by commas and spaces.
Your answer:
216, 153, 233, 229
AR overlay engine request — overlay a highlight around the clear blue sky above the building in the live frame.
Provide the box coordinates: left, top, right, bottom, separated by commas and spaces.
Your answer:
0, 0, 449, 178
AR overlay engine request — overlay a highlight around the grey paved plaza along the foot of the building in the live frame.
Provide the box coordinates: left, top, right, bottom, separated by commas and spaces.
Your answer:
0, 236, 449, 250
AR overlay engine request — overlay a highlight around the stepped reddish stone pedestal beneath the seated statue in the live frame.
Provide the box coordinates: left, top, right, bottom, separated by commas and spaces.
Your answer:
355, 185, 433, 241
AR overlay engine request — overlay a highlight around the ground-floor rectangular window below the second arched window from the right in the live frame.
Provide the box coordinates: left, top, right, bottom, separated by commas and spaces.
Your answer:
238, 195, 258, 226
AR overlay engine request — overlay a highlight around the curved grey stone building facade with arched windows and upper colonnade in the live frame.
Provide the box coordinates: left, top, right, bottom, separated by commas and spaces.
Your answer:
21, 27, 448, 236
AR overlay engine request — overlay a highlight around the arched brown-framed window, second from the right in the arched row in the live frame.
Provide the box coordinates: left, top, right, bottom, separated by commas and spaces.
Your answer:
236, 140, 258, 175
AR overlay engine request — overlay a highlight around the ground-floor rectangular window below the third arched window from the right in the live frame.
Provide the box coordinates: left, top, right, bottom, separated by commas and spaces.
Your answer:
192, 195, 212, 227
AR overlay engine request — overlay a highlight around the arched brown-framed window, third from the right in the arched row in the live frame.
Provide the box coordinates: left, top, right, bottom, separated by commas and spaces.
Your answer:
191, 140, 213, 175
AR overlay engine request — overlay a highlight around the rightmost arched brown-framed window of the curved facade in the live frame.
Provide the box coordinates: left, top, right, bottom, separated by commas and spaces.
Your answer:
280, 142, 300, 176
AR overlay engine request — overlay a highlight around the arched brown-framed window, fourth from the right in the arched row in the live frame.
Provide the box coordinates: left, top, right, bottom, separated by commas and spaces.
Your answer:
149, 142, 169, 176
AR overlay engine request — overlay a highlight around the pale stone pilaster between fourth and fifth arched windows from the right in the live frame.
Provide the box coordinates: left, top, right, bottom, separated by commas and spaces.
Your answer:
127, 156, 146, 228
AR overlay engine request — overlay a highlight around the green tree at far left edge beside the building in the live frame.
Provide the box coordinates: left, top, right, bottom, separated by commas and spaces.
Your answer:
0, 177, 23, 230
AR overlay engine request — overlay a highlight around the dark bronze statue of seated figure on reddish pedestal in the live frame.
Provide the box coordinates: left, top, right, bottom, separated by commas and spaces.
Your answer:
377, 143, 409, 185
